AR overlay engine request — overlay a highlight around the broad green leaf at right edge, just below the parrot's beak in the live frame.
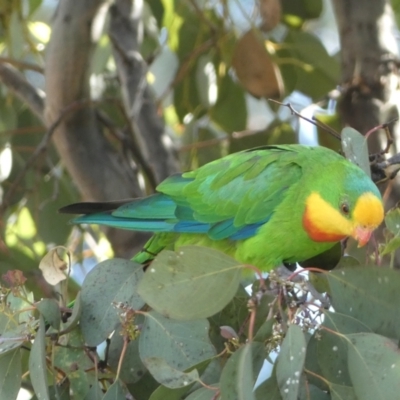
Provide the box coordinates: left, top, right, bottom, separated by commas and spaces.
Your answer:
327, 266, 400, 338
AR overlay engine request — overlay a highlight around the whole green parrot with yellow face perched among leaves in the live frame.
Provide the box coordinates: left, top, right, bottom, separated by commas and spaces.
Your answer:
60, 145, 384, 271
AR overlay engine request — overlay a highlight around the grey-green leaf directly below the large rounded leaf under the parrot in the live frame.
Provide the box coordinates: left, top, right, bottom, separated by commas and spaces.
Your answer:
139, 311, 215, 380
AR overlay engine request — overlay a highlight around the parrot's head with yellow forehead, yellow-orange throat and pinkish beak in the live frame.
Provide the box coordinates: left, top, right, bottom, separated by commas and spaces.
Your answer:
303, 166, 384, 247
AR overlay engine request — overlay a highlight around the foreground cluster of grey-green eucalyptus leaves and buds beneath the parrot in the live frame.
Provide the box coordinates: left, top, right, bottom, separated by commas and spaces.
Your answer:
0, 242, 400, 400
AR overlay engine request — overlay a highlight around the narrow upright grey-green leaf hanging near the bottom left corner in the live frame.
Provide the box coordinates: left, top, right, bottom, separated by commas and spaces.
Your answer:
29, 315, 50, 400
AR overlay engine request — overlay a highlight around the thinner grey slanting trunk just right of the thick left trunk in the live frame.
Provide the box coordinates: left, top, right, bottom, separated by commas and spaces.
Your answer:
110, 0, 178, 182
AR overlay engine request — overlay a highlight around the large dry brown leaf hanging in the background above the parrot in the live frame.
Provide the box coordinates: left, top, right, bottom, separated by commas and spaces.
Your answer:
232, 30, 283, 99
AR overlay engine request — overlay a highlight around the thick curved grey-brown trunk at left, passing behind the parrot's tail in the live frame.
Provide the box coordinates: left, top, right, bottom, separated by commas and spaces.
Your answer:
45, 0, 150, 256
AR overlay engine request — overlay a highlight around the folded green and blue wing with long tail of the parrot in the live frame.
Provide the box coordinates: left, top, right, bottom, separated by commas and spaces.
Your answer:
61, 145, 309, 240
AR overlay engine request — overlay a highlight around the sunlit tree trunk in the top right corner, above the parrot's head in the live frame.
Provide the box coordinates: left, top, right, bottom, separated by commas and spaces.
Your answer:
333, 0, 399, 134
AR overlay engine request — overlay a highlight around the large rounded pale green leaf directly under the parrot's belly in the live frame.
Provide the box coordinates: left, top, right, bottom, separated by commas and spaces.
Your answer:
138, 246, 241, 320
